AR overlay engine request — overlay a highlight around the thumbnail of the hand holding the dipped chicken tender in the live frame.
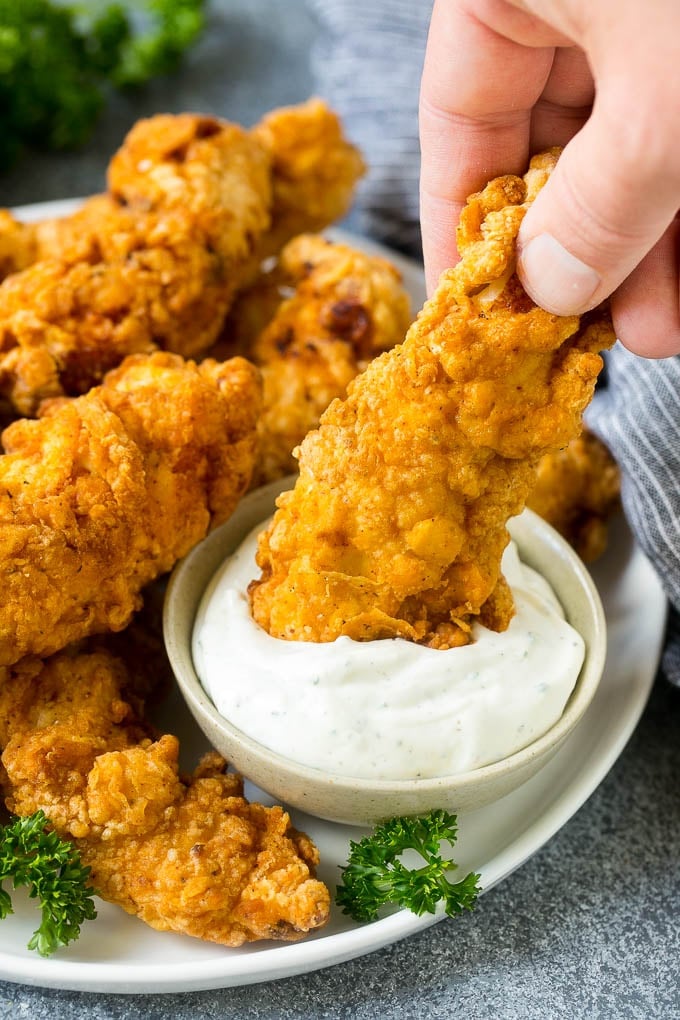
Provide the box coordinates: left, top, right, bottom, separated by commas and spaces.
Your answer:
518, 234, 601, 315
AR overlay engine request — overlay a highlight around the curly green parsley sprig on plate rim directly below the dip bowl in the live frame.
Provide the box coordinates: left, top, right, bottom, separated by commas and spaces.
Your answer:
335, 810, 480, 921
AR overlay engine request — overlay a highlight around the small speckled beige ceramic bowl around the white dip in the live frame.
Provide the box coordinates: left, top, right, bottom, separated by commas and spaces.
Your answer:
163, 479, 607, 824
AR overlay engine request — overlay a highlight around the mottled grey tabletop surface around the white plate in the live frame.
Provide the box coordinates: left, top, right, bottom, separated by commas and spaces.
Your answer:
0, 0, 680, 1020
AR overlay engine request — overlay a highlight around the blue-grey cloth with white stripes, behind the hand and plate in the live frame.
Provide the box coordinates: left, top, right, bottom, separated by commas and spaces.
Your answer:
309, 0, 680, 686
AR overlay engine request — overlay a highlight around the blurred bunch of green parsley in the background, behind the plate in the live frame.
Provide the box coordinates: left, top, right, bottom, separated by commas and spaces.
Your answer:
0, 0, 206, 169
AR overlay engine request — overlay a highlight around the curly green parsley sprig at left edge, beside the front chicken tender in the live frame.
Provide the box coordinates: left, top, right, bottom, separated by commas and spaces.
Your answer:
0, 811, 97, 957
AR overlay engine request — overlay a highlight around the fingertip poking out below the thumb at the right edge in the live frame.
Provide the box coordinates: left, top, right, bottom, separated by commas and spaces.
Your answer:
612, 217, 680, 358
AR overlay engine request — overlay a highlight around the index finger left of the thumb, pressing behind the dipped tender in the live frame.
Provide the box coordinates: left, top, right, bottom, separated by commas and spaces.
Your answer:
420, 0, 558, 292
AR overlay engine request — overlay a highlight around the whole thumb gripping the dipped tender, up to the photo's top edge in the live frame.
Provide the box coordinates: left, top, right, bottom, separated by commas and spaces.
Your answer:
518, 0, 680, 326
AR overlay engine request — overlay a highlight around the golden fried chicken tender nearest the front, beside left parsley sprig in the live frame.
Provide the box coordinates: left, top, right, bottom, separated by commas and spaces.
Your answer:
0, 652, 329, 946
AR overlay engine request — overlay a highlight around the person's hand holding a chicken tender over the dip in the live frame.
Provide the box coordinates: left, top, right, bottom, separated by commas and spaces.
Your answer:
420, 0, 680, 357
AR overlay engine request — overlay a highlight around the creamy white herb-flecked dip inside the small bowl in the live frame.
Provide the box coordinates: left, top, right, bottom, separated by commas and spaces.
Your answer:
193, 524, 585, 779
